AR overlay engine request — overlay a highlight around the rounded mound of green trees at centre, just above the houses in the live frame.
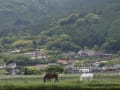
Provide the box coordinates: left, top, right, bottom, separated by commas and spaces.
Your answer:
45, 34, 80, 51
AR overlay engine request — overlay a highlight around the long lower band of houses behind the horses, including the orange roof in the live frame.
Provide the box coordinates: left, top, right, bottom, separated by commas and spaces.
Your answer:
36, 57, 120, 74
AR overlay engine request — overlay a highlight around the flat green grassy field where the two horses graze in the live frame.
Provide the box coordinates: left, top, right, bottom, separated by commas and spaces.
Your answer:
0, 74, 120, 90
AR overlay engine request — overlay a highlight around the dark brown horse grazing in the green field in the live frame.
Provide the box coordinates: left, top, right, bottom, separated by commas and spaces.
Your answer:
44, 73, 58, 82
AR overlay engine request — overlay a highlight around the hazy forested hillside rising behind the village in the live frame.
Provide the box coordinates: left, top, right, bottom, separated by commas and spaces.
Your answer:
0, 0, 120, 53
